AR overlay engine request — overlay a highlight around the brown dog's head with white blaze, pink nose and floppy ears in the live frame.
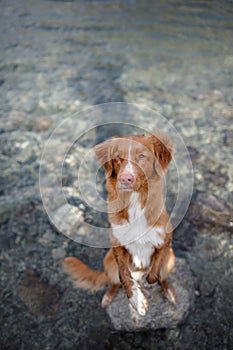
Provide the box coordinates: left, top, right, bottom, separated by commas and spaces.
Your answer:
95, 130, 173, 191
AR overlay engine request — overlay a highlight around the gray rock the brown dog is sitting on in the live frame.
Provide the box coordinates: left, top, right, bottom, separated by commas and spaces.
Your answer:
106, 258, 195, 332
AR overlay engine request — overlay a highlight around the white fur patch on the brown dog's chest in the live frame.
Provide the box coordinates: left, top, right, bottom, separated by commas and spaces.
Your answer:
111, 192, 164, 268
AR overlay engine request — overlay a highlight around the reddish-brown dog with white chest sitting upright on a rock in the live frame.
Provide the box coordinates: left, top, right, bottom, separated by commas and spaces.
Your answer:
63, 130, 176, 315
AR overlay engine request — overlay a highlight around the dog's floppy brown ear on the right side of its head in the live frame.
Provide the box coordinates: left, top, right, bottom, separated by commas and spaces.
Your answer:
149, 129, 174, 172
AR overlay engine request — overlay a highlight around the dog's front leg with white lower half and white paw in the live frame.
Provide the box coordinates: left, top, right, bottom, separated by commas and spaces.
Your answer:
113, 247, 148, 316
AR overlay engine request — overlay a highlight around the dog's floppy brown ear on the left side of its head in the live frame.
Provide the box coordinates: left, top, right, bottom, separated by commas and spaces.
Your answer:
95, 140, 114, 177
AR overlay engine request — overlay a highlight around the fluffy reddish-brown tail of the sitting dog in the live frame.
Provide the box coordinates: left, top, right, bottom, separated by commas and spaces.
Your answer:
63, 257, 109, 292
